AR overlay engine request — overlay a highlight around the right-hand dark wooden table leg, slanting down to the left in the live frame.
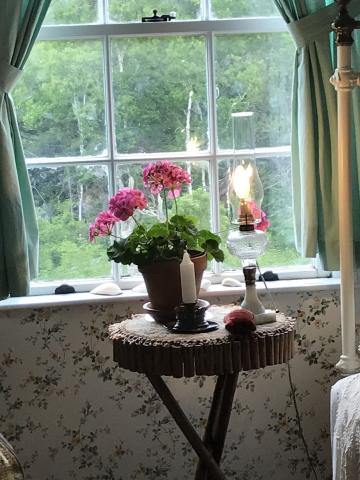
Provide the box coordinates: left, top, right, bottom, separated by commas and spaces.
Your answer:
195, 373, 239, 480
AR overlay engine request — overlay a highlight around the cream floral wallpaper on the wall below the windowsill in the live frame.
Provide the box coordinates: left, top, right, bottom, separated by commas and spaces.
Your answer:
0, 291, 341, 480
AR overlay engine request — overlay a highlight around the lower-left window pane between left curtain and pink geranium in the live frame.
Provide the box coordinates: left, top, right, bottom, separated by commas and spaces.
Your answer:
29, 166, 111, 280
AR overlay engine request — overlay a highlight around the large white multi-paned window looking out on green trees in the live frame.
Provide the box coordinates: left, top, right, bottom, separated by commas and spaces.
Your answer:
14, 0, 309, 292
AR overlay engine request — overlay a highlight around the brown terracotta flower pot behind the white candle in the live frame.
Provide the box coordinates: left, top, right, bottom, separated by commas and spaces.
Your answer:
139, 253, 207, 323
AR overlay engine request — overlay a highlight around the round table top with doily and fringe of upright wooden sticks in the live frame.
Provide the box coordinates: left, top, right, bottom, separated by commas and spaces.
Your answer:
109, 305, 295, 377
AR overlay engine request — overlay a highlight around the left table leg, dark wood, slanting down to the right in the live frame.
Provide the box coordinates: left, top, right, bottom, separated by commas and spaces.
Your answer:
147, 374, 226, 480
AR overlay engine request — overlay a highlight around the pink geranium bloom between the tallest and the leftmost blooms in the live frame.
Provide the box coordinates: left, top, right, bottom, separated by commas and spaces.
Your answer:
109, 187, 147, 221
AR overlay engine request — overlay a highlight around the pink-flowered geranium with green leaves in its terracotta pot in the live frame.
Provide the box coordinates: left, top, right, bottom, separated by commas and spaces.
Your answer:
89, 160, 224, 315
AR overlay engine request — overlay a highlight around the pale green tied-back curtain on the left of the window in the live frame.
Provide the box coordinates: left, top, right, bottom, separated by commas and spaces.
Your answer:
0, 0, 51, 298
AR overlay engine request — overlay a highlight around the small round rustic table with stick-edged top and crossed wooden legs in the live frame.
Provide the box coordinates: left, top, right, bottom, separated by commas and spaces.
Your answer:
109, 305, 295, 480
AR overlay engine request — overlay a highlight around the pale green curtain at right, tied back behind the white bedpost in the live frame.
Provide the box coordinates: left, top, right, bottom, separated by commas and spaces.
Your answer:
273, 0, 360, 270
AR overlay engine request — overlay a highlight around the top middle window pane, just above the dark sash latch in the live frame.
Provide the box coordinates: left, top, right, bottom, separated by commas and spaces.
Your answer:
109, 0, 200, 22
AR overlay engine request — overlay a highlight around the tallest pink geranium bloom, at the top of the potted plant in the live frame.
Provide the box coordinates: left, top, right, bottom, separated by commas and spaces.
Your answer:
143, 160, 191, 198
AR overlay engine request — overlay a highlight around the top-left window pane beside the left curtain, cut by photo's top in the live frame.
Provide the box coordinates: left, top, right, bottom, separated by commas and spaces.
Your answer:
44, 0, 98, 25
